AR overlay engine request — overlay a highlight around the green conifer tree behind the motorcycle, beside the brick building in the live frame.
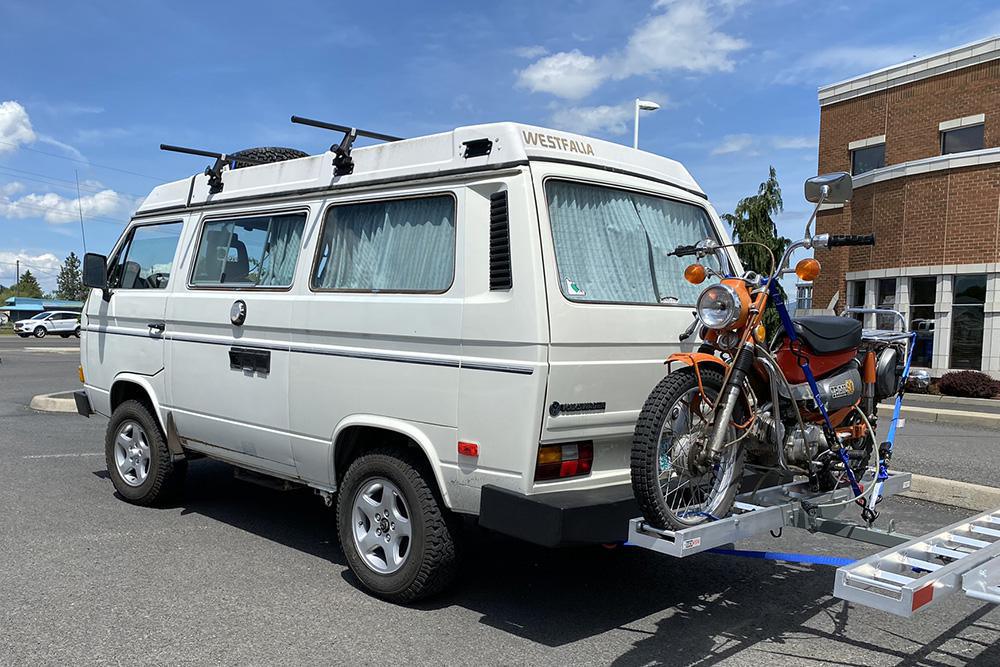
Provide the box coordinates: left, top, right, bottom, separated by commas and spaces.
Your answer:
722, 166, 791, 333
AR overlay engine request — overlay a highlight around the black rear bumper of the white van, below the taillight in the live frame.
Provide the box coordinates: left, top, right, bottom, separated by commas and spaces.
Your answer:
479, 484, 640, 547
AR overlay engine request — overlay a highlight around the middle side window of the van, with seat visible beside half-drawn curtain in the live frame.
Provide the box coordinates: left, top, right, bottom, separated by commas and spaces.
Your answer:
191, 213, 306, 287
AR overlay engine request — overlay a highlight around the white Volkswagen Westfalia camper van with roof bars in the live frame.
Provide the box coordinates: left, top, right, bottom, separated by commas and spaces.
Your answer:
77, 118, 732, 601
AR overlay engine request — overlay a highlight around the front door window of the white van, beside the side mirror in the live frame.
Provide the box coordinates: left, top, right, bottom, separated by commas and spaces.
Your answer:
108, 222, 183, 289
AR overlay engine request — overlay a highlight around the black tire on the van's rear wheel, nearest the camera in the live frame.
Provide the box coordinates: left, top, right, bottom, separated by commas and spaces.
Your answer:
337, 449, 460, 604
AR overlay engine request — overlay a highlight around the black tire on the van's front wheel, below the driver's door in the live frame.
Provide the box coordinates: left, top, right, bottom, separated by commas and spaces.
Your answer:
104, 400, 187, 505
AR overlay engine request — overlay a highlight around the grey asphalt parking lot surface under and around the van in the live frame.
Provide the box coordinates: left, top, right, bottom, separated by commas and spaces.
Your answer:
0, 337, 1000, 666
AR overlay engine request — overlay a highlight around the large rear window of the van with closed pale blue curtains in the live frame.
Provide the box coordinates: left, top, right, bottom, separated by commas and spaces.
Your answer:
545, 181, 719, 305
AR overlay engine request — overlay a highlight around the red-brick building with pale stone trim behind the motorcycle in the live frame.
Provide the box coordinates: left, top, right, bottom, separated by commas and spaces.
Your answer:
813, 38, 1000, 377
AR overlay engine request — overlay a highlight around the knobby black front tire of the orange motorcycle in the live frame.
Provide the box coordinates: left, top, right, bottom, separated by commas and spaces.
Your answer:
632, 367, 746, 530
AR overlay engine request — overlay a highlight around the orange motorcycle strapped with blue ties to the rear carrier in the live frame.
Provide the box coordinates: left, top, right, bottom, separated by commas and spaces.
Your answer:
632, 173, 925, 530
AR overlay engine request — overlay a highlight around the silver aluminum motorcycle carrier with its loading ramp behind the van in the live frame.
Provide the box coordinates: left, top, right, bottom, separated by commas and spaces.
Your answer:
629, 472, 1000, 617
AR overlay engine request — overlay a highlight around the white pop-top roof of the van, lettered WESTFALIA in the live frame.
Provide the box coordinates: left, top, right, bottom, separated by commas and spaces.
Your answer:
137, 123, 703, 214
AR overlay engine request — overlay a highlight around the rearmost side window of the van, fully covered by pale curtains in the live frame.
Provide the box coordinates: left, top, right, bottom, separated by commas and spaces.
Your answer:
312, 195, 455, 292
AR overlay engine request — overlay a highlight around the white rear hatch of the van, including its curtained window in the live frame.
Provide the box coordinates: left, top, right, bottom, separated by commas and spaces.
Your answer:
532, 163, 726, 491
